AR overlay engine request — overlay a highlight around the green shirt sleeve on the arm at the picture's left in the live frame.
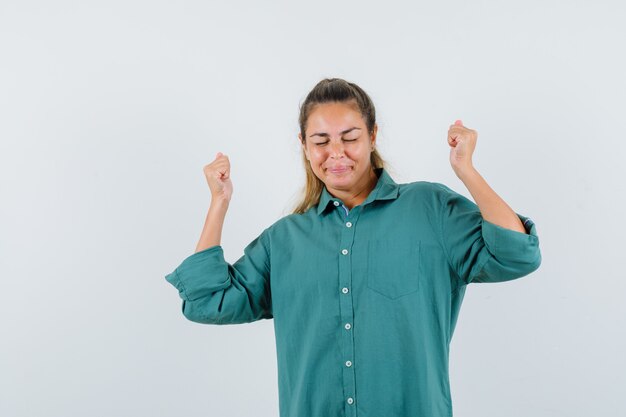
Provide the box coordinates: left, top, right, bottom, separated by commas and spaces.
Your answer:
165, 229, 273, 324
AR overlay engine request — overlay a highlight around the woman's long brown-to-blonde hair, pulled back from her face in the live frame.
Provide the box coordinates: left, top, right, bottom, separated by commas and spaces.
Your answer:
293, 78, 387, 214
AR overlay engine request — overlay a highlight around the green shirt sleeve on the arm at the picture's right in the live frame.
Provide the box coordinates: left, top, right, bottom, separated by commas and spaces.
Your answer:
440, 184, 541, 285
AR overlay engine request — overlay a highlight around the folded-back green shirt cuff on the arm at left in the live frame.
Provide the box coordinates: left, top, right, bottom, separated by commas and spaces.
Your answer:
165, 245, 230, 301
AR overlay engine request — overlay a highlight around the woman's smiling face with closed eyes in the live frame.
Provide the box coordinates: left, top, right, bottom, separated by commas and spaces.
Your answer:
298, 102, 378, 193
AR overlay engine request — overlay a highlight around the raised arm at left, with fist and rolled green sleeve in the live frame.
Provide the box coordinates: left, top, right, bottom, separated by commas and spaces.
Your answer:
165, 153, 273, 324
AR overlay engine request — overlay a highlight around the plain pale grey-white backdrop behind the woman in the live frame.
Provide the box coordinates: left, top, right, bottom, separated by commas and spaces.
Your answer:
0, 0, 626, 417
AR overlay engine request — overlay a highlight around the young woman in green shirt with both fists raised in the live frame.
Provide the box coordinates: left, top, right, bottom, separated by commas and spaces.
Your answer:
166, 78, 541, 417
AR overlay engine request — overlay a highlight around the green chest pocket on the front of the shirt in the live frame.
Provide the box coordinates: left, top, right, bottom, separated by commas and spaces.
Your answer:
367, 239, 420, 299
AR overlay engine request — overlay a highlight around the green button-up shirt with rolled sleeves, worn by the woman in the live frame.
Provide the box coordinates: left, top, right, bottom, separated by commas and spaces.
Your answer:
165, 168, 541, 417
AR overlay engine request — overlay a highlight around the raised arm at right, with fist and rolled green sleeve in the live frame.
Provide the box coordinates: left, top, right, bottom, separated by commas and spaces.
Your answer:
438, 120, 541, 285
